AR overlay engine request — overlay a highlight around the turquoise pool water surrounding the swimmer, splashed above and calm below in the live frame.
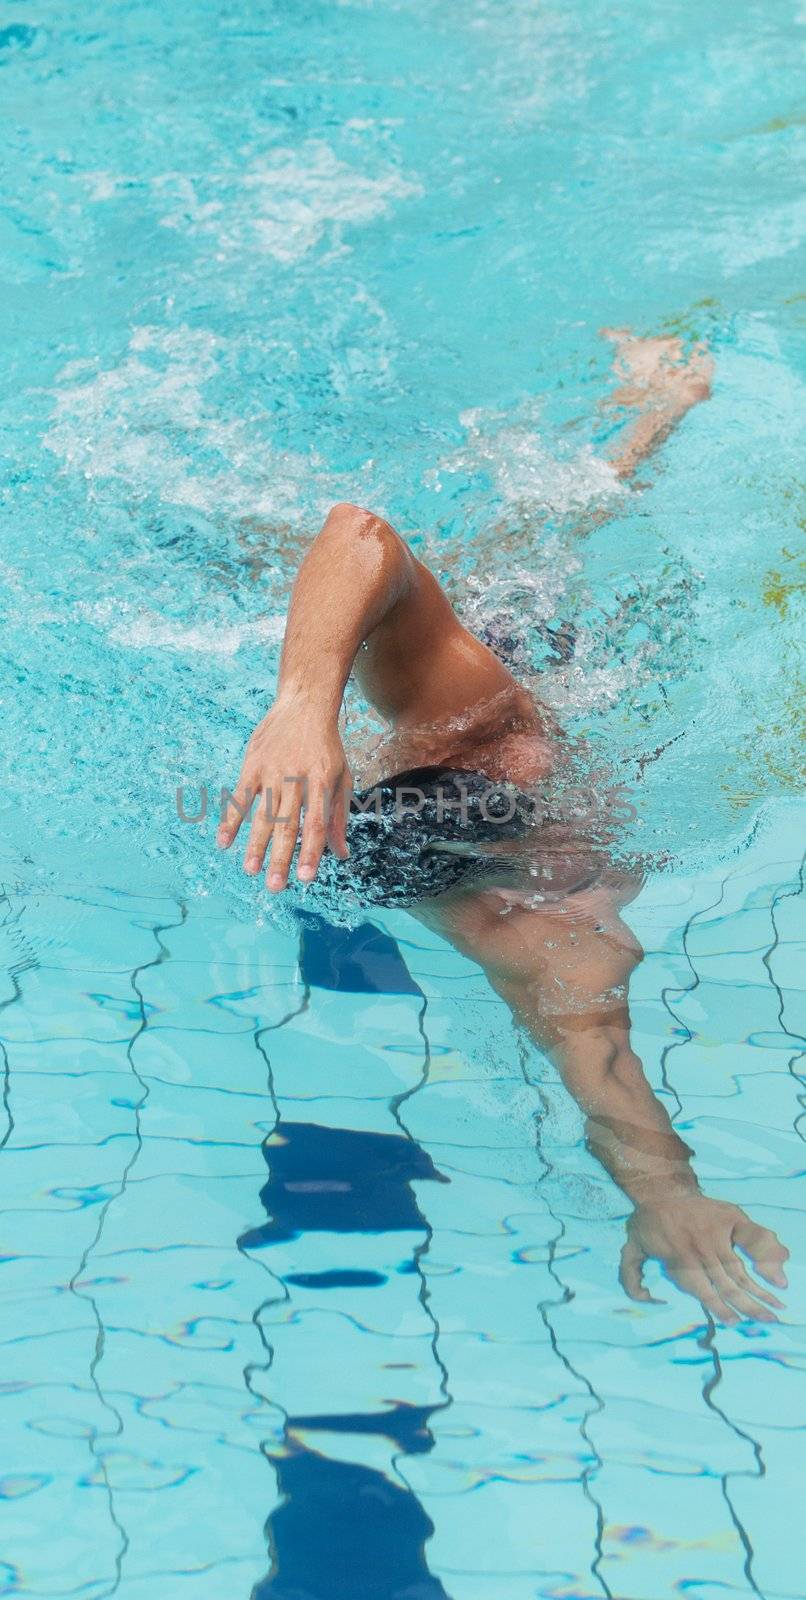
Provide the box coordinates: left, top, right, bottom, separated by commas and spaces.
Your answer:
0, 0, 806, 1600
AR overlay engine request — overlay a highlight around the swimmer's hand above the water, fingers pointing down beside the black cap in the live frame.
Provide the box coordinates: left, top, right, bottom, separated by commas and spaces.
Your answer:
217, 693, 352, 893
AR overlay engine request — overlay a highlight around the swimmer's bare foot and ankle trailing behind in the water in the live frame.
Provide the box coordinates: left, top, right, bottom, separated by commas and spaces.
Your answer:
601, 328, 713, 478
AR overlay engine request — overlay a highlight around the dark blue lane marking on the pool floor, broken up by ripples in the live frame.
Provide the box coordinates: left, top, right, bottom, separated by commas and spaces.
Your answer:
247, 917, 449, 1600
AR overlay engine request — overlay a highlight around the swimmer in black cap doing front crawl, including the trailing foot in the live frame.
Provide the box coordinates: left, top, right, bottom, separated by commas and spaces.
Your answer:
219, 330, 788, 1323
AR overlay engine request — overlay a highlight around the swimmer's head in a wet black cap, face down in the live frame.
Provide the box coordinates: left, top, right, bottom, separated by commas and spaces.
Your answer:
311, 766, 536, 906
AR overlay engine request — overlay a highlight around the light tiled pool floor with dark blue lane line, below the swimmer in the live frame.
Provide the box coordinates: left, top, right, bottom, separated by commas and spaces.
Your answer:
0, 806, 806, 1600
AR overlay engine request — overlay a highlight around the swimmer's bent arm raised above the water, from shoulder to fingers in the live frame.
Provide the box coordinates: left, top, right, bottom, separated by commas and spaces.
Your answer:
219, 506, 523, 891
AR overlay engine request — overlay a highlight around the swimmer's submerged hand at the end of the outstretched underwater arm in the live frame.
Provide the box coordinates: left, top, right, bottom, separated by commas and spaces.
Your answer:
619, 1190, 788, 1323
